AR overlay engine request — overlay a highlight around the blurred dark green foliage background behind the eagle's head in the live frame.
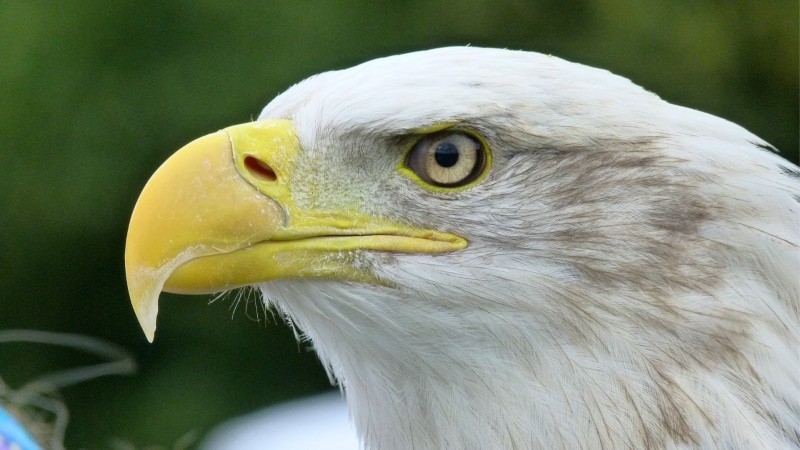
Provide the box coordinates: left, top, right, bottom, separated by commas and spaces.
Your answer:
0, 0, 799, 449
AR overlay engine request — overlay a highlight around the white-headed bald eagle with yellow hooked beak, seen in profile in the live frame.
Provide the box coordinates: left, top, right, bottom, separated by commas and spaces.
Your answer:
125, 47, 800, 449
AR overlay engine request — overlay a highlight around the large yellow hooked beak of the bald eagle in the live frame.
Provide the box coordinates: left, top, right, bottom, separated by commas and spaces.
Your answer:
125, 120, 467, 342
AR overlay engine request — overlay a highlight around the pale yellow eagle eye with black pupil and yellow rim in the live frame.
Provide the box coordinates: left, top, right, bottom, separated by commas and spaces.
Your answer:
405, 131, 487, 188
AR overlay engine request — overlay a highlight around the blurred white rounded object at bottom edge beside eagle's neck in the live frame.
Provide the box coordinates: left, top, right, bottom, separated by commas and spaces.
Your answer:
200, 392, 360, 450
